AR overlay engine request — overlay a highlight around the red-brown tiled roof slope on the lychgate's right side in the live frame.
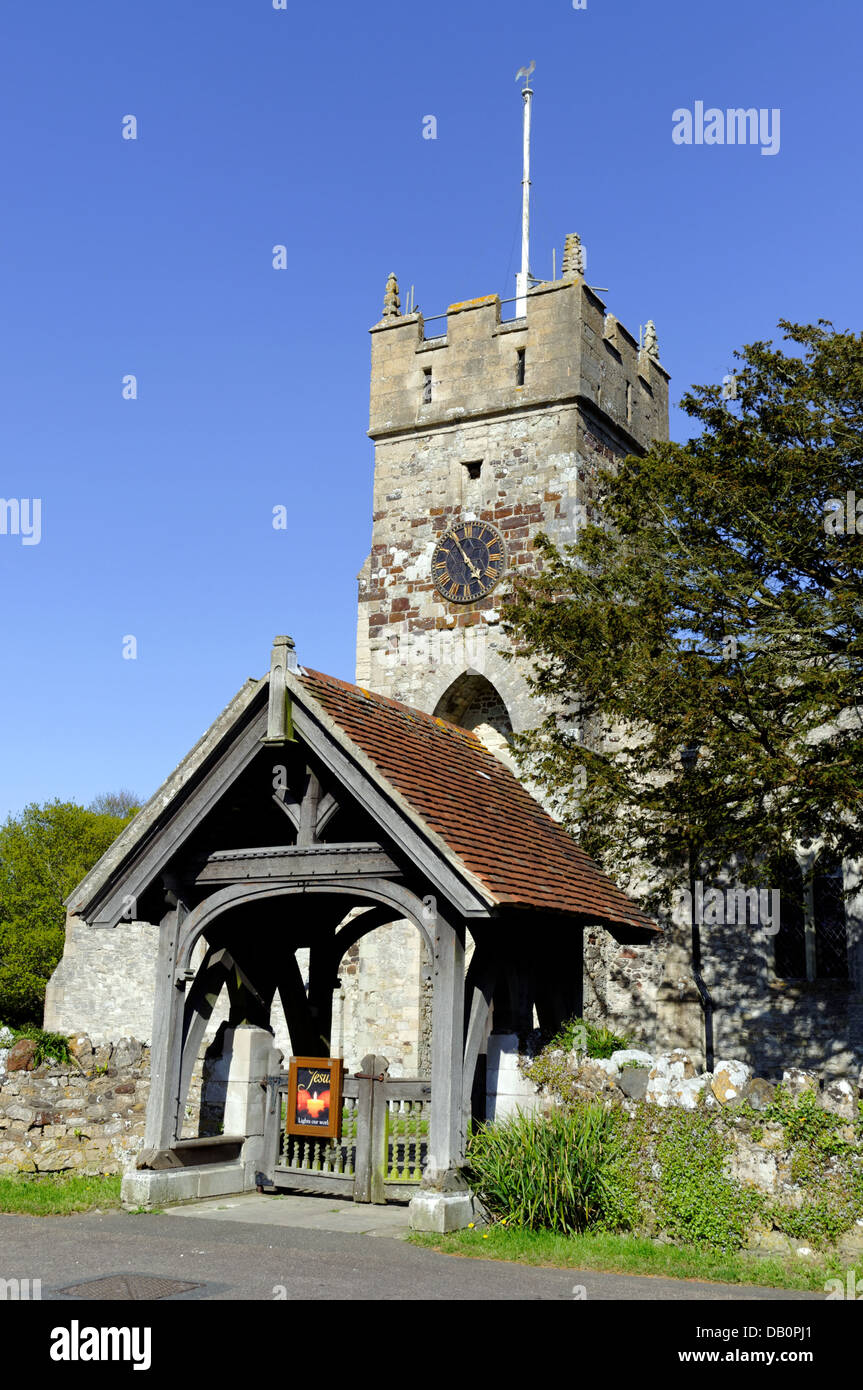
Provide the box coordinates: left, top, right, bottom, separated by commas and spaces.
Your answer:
297, 670, 659, 933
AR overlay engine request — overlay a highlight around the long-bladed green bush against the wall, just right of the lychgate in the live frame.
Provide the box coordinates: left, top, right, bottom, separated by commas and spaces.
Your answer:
467, 1105, 616, 1234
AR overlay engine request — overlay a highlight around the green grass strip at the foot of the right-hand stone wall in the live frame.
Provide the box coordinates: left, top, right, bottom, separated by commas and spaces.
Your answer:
407, 1226, 844, 1293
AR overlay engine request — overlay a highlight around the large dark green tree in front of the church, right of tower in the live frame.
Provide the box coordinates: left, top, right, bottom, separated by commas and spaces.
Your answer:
507, 320, 863, 883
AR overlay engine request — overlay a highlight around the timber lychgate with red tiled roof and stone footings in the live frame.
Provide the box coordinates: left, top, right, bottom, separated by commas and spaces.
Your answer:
53, 638, 656, 1229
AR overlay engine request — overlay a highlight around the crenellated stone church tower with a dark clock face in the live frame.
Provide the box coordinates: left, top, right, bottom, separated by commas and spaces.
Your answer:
345, 247, 668, 1072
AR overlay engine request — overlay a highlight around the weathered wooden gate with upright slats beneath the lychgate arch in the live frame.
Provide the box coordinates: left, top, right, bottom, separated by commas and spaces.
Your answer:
258, 1054, 431, 1202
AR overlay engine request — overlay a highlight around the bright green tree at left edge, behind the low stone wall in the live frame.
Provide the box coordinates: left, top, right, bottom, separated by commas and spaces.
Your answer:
0, 801, 129, 1023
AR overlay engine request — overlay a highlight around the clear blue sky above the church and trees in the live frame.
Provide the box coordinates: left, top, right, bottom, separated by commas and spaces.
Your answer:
0, 0, 863, 815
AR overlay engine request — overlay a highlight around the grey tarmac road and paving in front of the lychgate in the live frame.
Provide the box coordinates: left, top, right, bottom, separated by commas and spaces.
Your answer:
0, 1193, 824, 1308
